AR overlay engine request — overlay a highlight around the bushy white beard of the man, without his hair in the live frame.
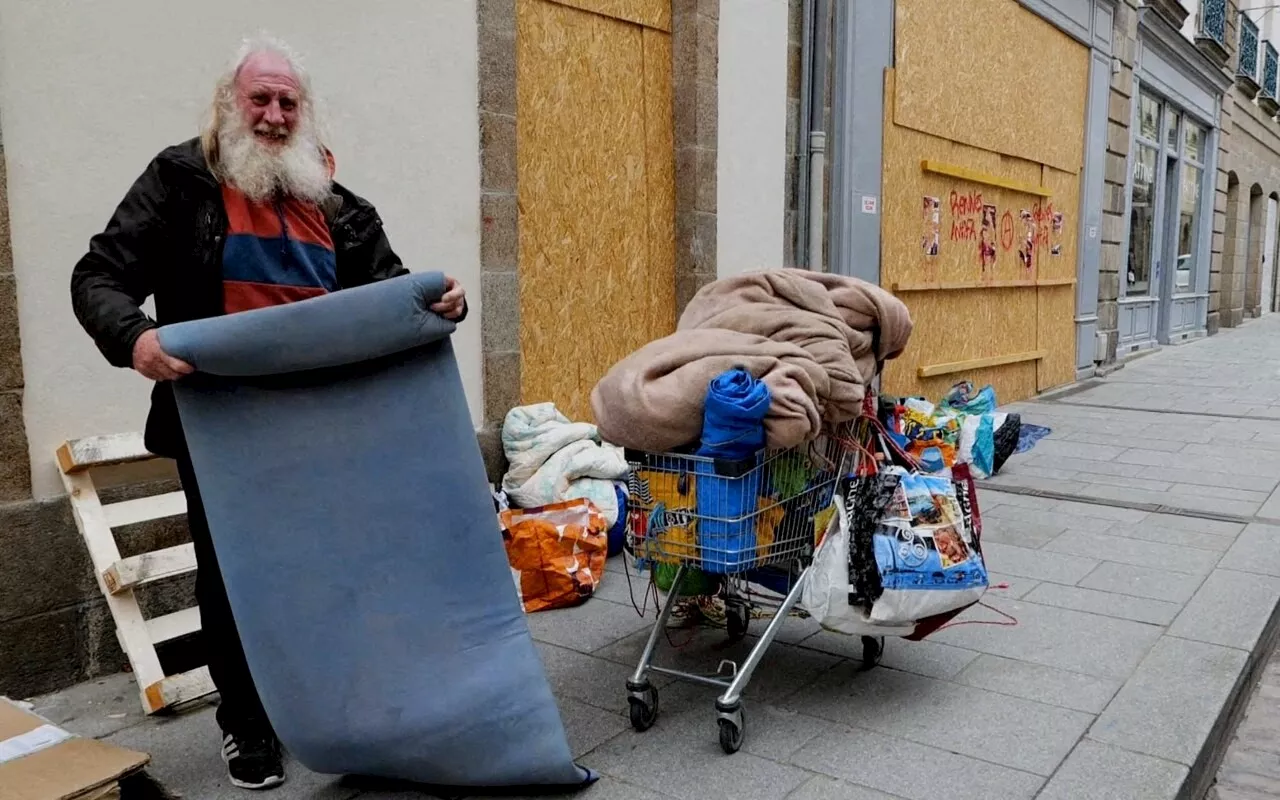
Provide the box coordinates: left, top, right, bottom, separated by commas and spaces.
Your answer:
218, 111, 332, 202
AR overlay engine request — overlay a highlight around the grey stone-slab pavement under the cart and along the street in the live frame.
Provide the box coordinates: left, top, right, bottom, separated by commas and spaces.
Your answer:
22, 317, 1280, 800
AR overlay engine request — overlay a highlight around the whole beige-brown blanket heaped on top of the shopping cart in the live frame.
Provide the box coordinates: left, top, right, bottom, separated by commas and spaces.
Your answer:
591, 269, 911, 451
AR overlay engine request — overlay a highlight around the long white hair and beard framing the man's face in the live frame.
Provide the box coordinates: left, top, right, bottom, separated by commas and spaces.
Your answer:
200, 35, 330, 201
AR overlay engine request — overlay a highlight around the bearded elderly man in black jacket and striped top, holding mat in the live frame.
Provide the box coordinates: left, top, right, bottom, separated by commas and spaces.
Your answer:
70, 35, 467, 788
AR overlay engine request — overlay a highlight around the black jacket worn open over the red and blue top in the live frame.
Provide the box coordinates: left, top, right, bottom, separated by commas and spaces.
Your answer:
70, 138, 466, 457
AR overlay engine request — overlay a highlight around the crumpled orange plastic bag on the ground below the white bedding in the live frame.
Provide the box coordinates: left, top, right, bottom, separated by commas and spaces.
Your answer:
499, 499, 609, 613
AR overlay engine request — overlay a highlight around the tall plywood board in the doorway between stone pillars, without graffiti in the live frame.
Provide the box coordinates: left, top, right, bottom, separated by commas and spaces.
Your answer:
516, 0, 675, 421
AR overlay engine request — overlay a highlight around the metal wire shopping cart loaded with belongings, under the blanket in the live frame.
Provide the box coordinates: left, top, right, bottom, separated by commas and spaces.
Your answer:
616, 424, 883, 754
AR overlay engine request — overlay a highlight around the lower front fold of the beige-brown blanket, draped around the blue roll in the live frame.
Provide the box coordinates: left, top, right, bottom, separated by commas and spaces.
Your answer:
591, 329, 829, 452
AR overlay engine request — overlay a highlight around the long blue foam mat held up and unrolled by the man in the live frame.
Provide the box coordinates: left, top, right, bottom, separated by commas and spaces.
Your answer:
159, 273, 595, 788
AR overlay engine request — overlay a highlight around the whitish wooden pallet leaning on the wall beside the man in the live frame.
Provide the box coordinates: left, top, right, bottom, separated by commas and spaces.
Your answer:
56, 433, 214, 714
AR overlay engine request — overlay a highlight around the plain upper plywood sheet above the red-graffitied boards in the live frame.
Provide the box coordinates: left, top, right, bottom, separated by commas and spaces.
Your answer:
886, 0, 1089, 173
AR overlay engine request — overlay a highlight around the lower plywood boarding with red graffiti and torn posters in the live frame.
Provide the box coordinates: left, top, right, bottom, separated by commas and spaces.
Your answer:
881, 70, 1083, 402
